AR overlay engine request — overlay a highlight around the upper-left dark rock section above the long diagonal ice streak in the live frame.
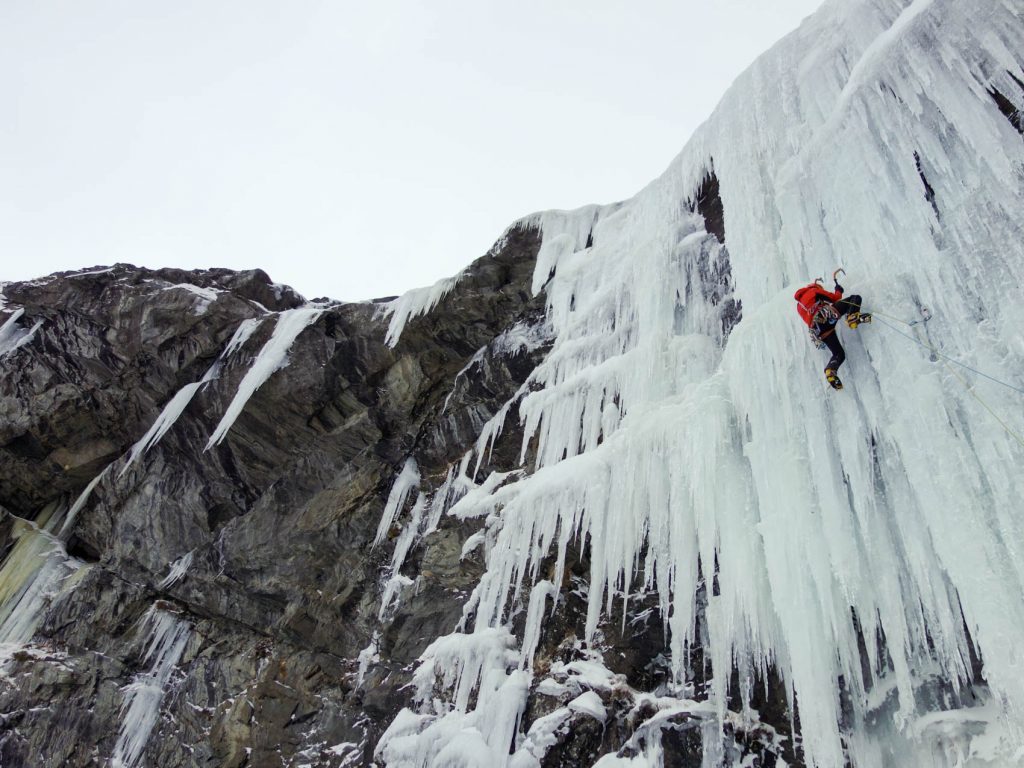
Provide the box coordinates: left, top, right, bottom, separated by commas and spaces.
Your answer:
0, 264, 301, 516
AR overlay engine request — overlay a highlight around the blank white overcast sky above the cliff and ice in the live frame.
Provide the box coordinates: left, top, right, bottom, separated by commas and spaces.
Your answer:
0, 0, 821, 300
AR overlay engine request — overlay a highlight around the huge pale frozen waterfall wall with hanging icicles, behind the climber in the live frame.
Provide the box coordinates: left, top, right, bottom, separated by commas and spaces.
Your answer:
379, 0, 1024, 768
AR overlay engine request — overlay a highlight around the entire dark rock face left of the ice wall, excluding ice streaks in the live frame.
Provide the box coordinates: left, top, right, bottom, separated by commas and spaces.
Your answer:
0, 229, 543, 766
